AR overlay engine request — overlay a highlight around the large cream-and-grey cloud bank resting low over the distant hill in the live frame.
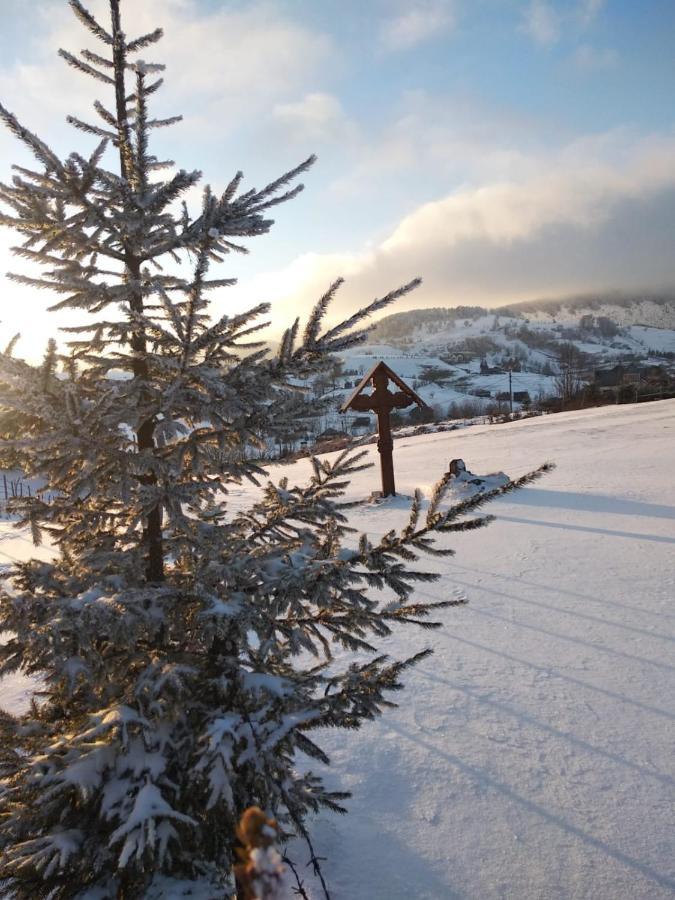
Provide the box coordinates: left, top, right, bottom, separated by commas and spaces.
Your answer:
239, 132, 675, 324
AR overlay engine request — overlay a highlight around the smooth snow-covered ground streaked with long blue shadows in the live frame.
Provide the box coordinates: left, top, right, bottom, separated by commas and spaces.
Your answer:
0, 401, 675, 900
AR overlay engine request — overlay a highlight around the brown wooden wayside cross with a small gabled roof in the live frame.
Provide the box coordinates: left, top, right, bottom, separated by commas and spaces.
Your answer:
340, 362, 427, 497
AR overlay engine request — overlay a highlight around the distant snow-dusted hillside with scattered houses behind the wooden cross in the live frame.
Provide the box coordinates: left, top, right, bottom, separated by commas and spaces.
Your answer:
310, 296, 675, 428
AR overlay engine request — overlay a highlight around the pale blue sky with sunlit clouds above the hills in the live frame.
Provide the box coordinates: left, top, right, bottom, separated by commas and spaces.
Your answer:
0, 0, 675, 358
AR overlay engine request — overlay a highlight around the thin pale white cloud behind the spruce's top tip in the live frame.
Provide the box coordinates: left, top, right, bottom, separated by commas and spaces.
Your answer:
0, 0, 338, 133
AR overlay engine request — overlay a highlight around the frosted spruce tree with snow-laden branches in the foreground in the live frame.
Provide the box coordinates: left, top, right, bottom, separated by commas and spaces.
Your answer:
0, 0, 548, 900
